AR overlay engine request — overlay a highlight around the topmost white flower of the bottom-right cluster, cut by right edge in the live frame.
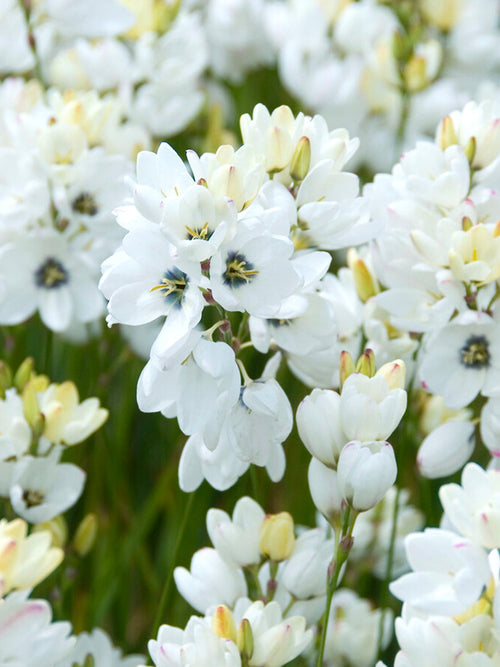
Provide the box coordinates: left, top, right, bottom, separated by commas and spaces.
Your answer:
439, 463, 500, 549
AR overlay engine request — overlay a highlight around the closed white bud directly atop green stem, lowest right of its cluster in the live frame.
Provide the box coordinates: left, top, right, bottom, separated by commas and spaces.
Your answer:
337, 440, 398, 512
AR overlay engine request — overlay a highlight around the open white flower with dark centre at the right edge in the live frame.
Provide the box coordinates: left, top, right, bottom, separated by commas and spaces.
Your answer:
419, 310, 500, 408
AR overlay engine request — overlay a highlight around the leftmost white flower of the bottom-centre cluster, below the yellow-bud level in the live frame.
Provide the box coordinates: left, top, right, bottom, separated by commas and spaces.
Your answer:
174, 547, 247, 614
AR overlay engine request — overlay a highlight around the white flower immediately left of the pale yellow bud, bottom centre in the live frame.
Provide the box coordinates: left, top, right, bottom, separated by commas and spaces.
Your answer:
207, 496, 265, 567
